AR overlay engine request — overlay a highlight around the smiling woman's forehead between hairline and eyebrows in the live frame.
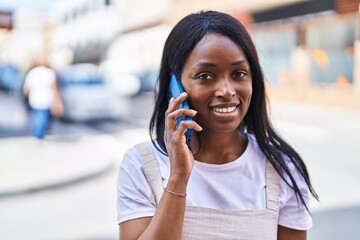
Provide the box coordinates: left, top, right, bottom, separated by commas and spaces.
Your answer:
187, 33, 247, 62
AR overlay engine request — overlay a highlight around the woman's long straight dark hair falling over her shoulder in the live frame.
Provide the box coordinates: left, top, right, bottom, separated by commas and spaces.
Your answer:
149, 11, 318, 208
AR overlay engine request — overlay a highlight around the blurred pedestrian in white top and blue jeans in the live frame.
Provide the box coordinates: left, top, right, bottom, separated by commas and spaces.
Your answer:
23, 62, 63, 140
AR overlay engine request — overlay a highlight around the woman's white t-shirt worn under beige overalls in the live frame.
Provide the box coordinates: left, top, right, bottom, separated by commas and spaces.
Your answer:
117, 135, 312, 230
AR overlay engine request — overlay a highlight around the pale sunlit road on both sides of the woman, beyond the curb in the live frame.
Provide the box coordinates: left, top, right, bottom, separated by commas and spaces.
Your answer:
0, 91, 360, 240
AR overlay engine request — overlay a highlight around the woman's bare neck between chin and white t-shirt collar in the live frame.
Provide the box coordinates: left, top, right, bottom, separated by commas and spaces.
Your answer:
191, 130, 247, 164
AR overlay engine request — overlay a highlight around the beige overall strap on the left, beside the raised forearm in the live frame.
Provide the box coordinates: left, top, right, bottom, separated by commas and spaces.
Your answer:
136, 142, 164, 205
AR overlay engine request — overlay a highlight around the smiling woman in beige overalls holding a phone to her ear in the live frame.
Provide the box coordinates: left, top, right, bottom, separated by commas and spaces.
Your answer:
118, 11, 317, 240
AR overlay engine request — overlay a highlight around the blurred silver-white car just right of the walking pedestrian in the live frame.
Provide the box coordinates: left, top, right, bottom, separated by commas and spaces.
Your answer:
58, 64, 130, 121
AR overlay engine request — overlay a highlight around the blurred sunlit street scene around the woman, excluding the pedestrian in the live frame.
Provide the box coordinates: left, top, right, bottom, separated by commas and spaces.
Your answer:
0, 0, 360, 240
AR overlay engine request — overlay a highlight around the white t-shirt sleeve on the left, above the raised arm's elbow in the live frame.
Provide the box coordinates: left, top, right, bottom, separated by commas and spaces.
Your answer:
117, 148, 156, 224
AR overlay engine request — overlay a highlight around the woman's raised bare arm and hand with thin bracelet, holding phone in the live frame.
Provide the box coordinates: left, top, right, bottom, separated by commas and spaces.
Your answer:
119, 94, 202, 240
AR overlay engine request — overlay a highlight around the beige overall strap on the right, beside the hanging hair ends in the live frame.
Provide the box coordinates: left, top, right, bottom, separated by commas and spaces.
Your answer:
266, 161, 280, 212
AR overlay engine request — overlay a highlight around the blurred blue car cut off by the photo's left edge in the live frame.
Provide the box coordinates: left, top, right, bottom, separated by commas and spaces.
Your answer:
0, 64, 24, 92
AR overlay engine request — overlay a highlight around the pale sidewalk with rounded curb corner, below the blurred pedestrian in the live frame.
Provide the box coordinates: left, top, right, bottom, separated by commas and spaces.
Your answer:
0, 134, 122, 198
